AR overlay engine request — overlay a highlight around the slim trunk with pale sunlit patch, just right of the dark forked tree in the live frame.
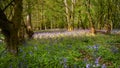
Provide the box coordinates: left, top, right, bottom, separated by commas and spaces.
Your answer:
24, 0, 34, 38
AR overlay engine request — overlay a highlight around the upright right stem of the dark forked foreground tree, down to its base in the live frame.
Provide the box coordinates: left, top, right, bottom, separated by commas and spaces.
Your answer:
10, 0, 23, 54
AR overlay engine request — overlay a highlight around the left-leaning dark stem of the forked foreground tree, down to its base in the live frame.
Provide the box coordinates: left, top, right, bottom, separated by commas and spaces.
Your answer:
0, 9, 19, 55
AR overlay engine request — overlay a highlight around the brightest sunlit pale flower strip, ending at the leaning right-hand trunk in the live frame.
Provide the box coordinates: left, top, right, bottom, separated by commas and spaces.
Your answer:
33, 30, 90, 39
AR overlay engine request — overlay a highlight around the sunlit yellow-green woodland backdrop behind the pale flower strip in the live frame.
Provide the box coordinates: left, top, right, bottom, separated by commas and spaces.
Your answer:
20, 0, 120, 33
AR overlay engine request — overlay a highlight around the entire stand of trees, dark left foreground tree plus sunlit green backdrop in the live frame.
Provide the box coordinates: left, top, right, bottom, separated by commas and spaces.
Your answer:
0, 0, 120, 53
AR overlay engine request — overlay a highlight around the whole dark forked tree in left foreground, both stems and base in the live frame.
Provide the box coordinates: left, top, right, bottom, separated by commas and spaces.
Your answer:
0, 0, 23, 55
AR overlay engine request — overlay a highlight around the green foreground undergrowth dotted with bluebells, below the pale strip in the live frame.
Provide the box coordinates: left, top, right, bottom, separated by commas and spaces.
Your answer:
0, 35, 120, 68
